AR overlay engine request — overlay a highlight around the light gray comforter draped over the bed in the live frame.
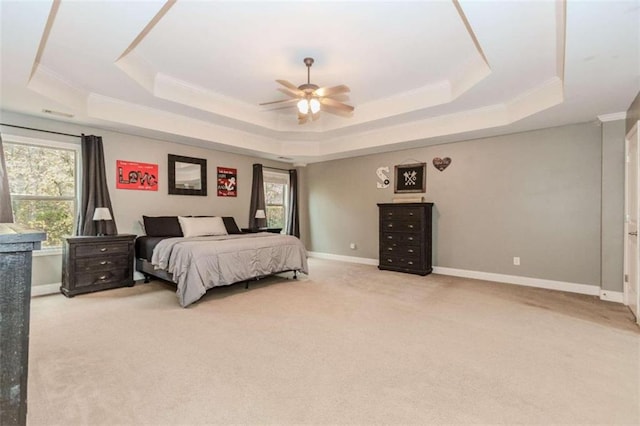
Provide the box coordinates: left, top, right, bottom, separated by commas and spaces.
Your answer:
151, 232, 309, 307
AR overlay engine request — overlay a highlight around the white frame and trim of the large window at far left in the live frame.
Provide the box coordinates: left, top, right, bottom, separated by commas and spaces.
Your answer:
2, 133, 82, 251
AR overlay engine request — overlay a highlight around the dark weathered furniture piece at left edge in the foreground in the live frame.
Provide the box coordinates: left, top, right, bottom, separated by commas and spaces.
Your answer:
0, 223, 46, 426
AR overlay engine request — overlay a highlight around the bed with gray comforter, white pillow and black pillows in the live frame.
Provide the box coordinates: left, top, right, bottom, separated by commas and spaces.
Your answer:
135, 216, 309, 307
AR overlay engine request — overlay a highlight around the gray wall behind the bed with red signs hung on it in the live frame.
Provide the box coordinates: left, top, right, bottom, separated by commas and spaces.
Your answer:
2, 112, 290, 285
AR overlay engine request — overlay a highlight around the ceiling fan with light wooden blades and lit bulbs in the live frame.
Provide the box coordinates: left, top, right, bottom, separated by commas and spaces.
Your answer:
260, 58, 354, 124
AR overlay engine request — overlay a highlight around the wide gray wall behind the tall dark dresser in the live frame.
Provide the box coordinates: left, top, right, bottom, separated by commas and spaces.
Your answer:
304, 123, 604, 290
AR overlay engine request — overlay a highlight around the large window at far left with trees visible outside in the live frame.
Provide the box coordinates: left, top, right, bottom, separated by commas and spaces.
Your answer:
3, 136, 80, 249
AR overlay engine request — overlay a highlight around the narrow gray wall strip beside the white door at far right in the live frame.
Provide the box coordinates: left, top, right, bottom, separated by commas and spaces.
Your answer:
602, 120, 625, 291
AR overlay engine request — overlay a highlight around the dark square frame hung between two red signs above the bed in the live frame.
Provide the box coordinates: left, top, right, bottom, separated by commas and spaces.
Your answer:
167, 154, 207, 196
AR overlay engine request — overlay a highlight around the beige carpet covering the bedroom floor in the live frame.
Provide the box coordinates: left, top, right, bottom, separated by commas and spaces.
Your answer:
28, 259, 640, 425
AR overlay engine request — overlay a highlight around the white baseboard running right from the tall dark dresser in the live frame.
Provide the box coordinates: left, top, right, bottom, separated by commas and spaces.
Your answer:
433, 266, 600, 296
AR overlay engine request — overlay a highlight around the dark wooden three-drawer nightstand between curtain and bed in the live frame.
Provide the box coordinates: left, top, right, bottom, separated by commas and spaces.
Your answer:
60, 234, 136, 297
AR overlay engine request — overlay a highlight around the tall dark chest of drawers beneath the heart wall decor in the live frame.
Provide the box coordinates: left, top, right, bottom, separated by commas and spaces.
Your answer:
378, 203, 433, 275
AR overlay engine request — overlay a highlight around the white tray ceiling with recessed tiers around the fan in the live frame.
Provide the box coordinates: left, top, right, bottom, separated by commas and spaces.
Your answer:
0, 0, 640, 163
